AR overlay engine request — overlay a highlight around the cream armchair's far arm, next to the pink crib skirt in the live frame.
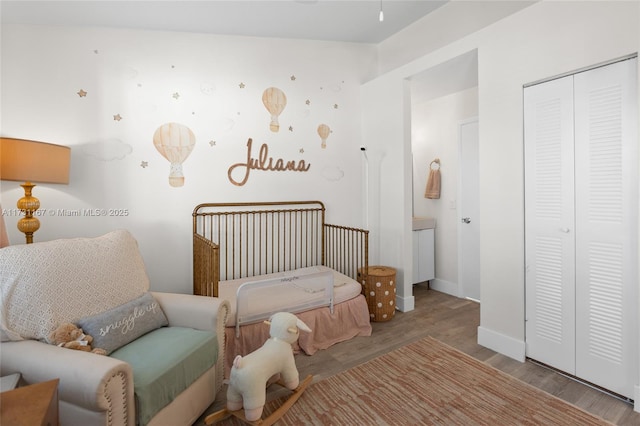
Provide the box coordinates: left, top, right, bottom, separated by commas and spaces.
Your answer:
152, 292, 229, 332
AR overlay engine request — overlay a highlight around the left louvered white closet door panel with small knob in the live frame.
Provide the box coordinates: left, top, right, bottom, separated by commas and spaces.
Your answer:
524, 77, 575, 374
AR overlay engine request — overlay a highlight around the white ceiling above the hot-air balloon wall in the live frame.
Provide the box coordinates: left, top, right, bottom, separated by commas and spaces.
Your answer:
0, 0, 447, 44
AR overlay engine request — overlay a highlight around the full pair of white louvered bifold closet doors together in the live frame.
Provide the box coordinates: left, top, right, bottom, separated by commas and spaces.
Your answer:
524, 59, 638, 398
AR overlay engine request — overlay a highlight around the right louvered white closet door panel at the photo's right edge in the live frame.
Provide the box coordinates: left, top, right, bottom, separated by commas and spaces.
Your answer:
574, 59, 638, 397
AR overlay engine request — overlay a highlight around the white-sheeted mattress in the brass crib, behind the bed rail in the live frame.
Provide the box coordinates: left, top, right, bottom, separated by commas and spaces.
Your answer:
218, 265, 362, 327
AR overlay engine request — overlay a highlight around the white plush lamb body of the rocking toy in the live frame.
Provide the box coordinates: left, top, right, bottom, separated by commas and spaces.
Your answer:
227, 312, 311, 421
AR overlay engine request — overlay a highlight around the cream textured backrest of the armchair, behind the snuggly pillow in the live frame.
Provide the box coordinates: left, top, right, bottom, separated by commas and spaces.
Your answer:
0, 230, 149, 340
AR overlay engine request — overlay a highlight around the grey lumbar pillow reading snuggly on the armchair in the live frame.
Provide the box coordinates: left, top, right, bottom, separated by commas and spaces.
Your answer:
78, 293, 169, 355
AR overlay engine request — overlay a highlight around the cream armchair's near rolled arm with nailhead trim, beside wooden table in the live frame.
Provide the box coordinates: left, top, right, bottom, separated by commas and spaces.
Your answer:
0, 340, 135, 416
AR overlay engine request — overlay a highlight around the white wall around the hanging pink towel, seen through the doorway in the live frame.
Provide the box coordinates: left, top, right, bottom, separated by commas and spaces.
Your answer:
411, 88, 478, 296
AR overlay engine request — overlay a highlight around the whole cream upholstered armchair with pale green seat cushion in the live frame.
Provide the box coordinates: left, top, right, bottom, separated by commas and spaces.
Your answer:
0, 230, 229, 426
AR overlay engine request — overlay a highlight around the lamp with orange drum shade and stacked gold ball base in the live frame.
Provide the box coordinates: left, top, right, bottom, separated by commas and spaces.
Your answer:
0, 138, 71, 244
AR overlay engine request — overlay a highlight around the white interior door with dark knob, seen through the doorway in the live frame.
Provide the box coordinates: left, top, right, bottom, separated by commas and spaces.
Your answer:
458, 118, 480, 301
